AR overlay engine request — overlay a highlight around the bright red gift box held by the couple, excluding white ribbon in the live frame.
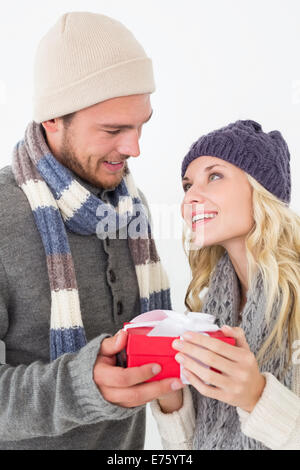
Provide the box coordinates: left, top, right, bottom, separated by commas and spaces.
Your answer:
124, 323, 235, 382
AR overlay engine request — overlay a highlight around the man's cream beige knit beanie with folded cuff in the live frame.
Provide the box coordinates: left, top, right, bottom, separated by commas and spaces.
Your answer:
33, 12, 155, 123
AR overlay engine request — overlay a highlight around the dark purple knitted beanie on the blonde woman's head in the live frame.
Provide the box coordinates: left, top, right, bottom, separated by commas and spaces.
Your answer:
181, 120, 291, 203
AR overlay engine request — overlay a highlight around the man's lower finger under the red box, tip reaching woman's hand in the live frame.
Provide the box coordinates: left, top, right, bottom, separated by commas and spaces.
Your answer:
102, 378, 184, 408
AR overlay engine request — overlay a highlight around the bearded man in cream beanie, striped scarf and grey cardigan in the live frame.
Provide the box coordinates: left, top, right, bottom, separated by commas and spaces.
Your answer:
0, 12, 183, 449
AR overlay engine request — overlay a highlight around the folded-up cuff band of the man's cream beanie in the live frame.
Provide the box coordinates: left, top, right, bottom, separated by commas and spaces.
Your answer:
33, 57, 155, 124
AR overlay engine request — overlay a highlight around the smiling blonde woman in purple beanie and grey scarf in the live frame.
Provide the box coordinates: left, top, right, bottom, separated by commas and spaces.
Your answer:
151, 120, 300, 449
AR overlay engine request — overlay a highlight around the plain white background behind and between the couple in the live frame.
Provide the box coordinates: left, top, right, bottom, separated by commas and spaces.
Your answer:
0, 0, 300, 449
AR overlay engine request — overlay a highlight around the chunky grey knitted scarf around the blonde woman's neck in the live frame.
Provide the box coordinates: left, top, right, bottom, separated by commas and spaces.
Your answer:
191, 252, 293, 450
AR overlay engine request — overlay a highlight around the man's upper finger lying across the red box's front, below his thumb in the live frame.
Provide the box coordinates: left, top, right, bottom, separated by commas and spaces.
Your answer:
94, 356, 161, 388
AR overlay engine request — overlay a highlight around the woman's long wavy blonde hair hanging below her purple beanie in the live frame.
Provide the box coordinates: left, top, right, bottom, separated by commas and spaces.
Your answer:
183, 173, 300, 363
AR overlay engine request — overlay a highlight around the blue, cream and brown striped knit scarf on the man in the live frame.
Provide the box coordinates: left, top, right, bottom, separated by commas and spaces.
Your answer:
12, 121, 171, 360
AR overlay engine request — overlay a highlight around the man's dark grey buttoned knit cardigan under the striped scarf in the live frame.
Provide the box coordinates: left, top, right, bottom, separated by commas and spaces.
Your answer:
0, 166, 146, 449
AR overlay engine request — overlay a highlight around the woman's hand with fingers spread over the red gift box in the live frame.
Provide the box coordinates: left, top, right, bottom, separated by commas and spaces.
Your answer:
172, 326, 265, 413
